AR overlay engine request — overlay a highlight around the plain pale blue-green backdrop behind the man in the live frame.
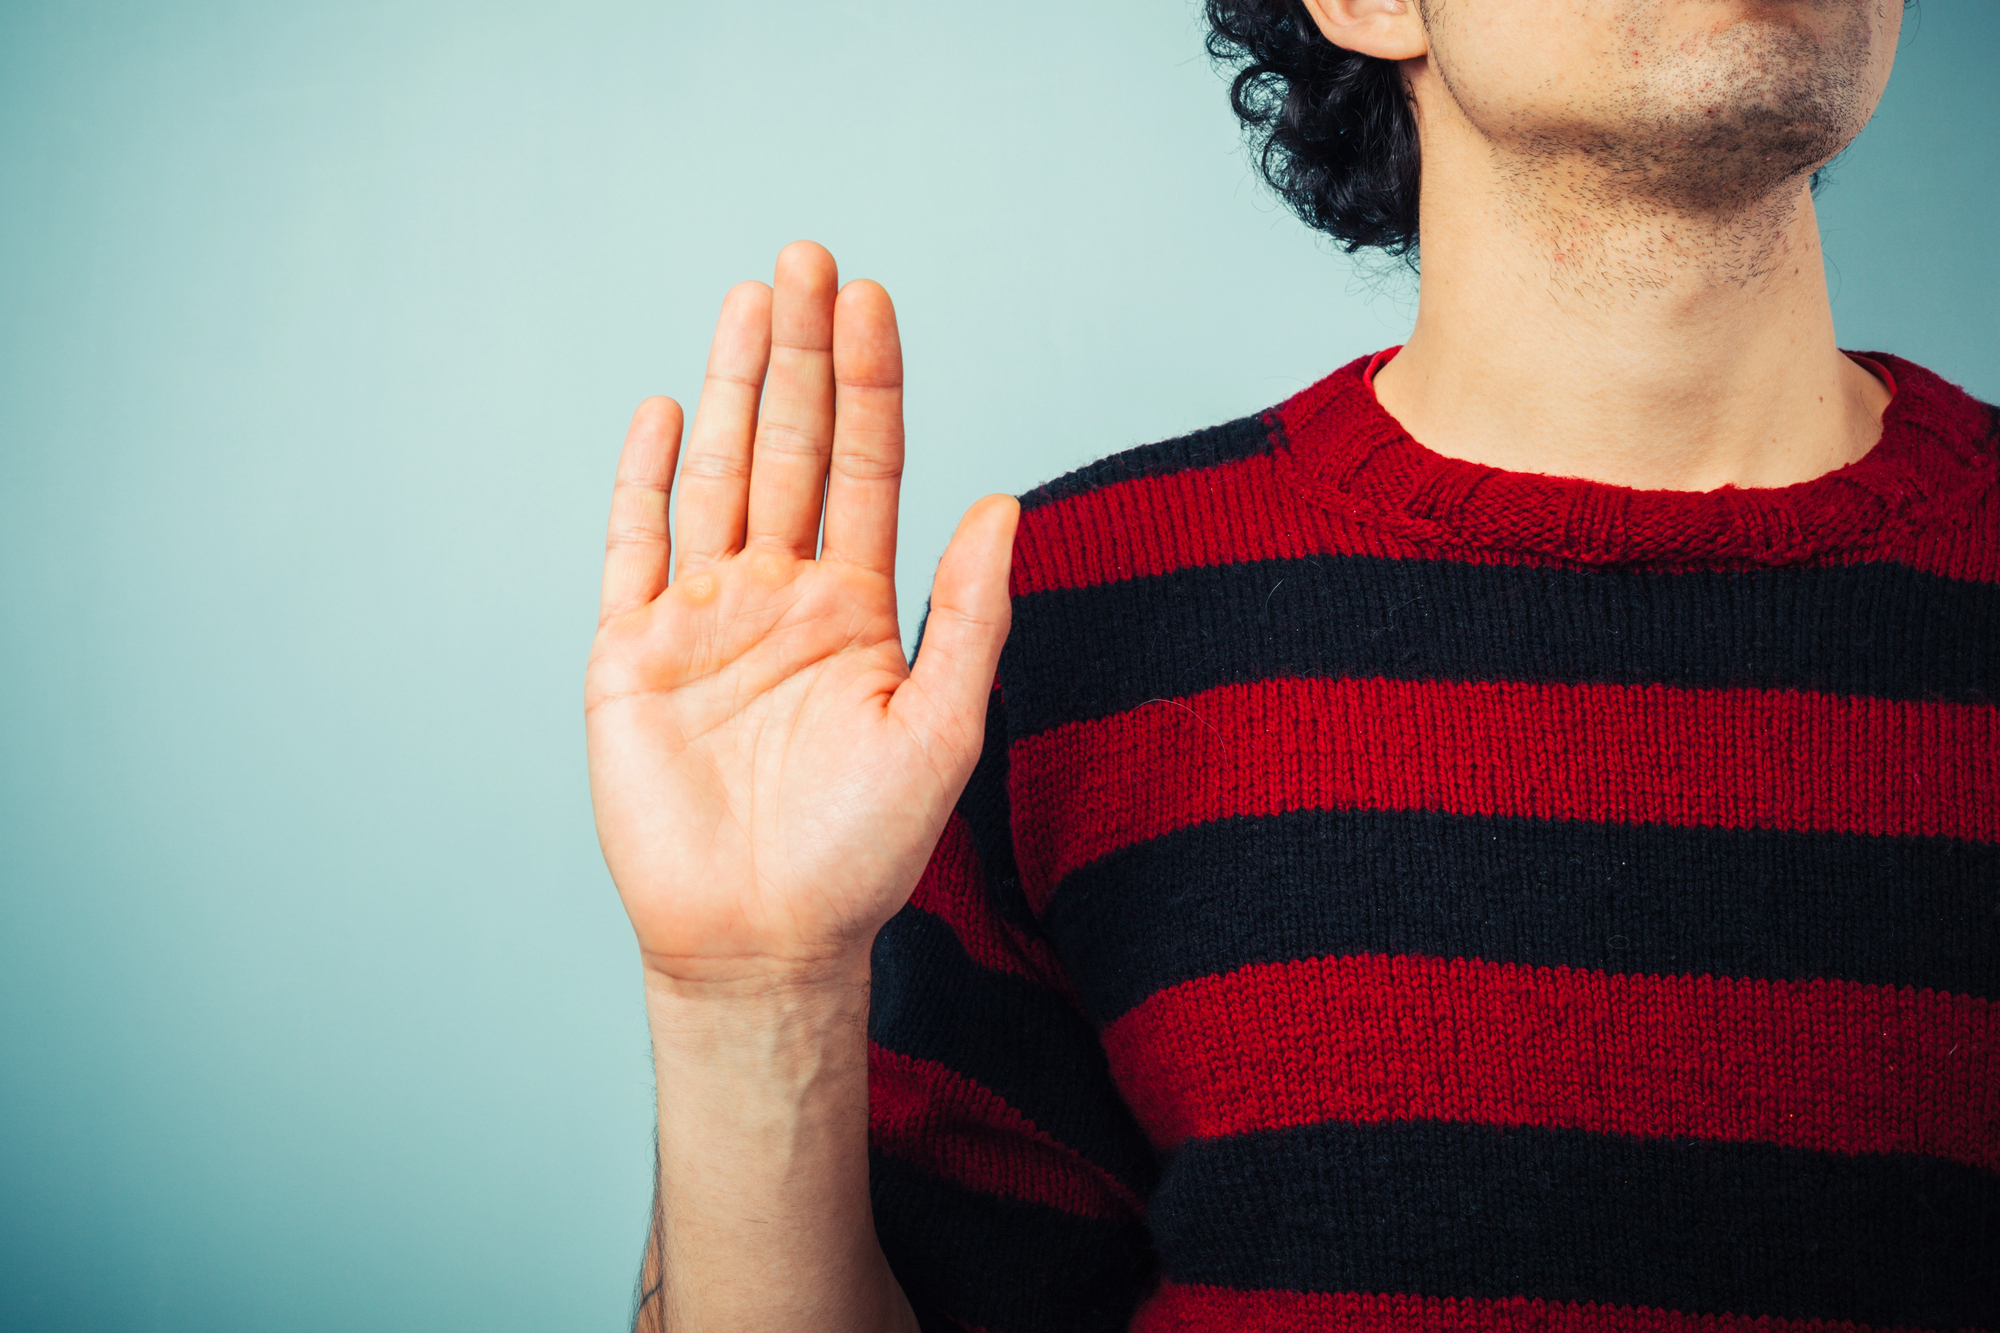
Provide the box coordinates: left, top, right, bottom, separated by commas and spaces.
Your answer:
0, 0, 2000, 1333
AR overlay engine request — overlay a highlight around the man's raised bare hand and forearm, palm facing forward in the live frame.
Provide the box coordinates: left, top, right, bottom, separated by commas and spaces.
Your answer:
584, 242, 1018, 1333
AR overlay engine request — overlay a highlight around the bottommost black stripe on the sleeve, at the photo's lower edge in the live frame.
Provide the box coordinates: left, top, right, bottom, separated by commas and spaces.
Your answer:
870, 1153, 1154, 1333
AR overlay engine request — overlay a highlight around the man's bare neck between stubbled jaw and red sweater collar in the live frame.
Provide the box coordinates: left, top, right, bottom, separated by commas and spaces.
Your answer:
1376, 105, 1888, 490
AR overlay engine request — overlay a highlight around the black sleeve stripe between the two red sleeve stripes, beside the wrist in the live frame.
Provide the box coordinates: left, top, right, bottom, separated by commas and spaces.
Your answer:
868, 907, 1158, 1197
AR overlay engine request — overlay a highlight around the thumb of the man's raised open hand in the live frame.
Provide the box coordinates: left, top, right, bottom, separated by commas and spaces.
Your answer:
890, 494, 1020, 781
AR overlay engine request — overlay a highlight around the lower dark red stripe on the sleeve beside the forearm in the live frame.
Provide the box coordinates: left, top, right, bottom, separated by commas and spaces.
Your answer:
868, 1043, 1140, 1219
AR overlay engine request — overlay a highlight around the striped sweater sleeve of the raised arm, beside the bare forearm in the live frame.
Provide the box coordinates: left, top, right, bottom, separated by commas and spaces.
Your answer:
868, 691, 1156, 1333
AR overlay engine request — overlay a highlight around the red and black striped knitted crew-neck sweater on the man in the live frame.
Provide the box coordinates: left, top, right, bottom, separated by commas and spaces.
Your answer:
870, 356, 2000, 1333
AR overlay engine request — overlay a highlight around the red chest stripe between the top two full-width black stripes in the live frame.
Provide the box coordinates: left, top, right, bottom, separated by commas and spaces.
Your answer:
1010, 681, 2000, 896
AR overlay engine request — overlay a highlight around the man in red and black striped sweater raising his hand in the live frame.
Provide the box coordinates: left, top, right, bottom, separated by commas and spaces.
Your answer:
588, 0, 2000, 1333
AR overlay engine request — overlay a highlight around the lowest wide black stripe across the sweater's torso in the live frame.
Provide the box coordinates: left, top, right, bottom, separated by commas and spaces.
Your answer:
1148, 1123, 2000, 1329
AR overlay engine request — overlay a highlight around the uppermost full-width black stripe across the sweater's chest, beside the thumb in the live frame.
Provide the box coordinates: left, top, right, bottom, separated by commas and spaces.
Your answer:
1002, 556, 2000, 737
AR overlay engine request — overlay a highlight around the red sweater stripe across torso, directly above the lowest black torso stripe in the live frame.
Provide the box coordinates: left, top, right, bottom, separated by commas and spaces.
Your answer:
1104, 955, 2000, 1171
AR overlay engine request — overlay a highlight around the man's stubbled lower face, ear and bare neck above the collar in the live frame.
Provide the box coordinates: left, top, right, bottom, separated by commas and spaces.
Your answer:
1306, 0, 1902, 490
